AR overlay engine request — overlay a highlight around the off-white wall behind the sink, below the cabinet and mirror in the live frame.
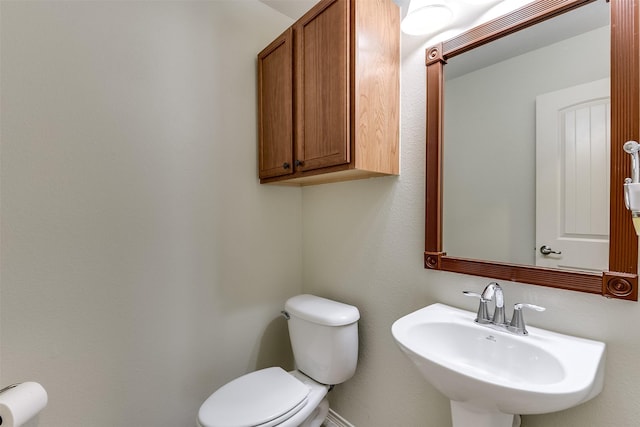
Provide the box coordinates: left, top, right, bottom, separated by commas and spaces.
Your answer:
303, 28, 640, 427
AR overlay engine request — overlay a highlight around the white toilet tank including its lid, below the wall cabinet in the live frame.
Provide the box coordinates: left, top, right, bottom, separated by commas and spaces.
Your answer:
285, 295, 360, 385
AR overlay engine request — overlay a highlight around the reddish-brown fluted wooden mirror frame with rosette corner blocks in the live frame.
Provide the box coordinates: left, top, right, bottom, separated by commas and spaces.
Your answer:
424, 0, 640, 301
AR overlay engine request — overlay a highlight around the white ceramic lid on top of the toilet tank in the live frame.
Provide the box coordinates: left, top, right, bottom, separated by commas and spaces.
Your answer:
284, 294, 360, 326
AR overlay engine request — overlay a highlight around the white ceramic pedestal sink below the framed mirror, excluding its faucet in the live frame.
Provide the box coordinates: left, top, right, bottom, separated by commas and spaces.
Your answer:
391, 304, 606, 427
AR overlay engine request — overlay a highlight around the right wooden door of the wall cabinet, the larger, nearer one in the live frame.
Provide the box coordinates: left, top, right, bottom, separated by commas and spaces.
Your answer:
294, 0, 350, 171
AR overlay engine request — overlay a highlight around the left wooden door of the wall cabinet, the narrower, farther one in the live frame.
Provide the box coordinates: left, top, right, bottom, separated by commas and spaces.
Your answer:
258, 28, 293, 178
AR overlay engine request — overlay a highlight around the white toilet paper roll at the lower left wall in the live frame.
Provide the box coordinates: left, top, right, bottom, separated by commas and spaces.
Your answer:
0, 382, 48, 427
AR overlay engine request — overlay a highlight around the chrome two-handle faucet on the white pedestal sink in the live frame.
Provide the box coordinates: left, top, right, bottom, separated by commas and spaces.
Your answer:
463, 282, 545, 335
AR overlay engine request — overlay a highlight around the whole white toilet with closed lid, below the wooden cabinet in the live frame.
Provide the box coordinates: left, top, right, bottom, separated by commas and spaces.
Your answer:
198, 295, 360, 427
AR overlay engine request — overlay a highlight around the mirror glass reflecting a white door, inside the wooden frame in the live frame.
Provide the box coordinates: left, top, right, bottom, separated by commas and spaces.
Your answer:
442, 1, 610, 271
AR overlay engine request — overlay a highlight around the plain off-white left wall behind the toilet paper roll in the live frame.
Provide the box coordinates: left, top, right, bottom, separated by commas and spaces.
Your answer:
0, 0, 302, 427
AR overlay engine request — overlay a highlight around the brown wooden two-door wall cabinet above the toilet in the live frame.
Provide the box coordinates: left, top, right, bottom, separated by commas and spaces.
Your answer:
258, 0, 400, 185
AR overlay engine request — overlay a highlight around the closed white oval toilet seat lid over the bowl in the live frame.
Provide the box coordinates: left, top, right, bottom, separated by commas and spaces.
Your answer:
198, 367, 309, 427
